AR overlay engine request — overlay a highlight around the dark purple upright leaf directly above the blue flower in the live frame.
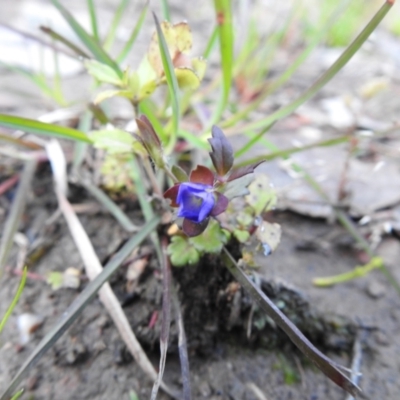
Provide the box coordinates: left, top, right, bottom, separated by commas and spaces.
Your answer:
208, 125, 233, 176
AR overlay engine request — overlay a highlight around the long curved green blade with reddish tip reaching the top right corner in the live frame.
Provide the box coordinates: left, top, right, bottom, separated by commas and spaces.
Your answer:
241, 0, 394, 130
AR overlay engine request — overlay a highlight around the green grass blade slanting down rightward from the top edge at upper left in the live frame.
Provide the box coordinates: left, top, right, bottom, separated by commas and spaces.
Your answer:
51, 0, 123, 78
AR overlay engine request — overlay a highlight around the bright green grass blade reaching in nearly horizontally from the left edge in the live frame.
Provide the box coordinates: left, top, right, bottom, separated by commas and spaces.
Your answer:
0, 114, 91, 143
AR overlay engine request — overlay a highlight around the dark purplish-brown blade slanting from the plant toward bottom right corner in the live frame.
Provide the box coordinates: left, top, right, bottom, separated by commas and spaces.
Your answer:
223, 248, 361, 396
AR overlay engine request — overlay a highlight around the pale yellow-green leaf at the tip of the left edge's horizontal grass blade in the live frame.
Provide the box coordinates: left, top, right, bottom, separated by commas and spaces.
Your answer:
89, 128, 136, 154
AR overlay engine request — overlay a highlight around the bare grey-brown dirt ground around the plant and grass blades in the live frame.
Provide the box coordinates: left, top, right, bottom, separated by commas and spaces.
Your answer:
0, 1, 400, 400
